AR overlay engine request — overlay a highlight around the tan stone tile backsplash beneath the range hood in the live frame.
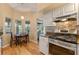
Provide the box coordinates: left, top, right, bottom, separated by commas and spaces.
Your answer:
56, 21, 77, 33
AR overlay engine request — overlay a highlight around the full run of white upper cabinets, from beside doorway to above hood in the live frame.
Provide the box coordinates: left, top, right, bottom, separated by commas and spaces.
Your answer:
39, 3, 78, 26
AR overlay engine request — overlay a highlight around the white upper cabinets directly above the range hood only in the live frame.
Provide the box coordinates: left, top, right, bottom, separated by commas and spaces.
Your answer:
53, 3, 77, 18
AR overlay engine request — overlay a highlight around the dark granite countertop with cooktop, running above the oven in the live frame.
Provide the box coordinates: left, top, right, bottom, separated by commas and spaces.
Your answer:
41, 32, 79, 44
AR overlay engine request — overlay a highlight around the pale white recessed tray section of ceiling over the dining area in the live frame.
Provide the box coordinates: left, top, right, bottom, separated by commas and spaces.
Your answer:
10, 3, 37, 12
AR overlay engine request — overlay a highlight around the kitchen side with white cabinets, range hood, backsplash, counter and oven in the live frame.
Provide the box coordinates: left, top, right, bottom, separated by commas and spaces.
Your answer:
39, 4, 79, 55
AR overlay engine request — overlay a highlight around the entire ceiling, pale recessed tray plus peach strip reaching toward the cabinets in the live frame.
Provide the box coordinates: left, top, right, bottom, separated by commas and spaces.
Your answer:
9, 3, 65, 12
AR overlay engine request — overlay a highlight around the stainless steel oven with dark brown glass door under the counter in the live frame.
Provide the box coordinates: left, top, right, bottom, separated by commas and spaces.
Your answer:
49, 39, 76, 55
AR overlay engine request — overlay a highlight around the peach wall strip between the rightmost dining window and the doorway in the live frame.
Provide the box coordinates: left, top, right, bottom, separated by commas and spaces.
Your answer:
30, 13, 42, 43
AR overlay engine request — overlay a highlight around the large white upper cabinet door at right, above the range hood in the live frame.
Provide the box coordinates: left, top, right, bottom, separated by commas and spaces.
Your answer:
63, 3, 75, 15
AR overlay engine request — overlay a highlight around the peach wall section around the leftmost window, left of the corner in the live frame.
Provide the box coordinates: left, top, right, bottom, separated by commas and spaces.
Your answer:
0, 4, 13, 46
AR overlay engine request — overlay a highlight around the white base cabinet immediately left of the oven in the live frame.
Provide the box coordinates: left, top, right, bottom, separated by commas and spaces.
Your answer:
39, 36, 49, 55
